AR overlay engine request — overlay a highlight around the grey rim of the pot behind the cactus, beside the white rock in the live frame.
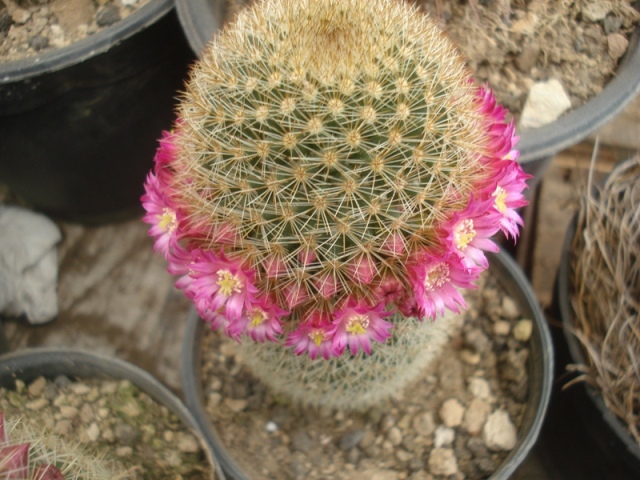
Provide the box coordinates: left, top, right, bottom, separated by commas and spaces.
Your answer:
176, 0, 640, 165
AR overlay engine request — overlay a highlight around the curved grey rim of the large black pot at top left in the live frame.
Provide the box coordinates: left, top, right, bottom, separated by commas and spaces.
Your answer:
0, 0, 174, 82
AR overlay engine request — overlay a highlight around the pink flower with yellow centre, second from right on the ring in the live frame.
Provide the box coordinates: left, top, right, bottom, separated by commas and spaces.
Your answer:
441, 197, 501, 268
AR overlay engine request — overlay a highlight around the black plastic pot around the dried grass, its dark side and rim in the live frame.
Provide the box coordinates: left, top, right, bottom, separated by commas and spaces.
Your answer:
540, 217, 640, 480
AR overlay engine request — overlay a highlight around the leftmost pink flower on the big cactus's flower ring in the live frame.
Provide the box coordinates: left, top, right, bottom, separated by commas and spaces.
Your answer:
141, 173, 178, 258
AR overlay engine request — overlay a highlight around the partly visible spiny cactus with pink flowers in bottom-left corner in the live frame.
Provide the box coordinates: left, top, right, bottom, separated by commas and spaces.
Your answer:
0, 412, 119, 480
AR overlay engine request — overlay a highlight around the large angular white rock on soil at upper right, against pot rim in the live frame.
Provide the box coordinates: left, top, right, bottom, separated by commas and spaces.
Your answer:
520, 79, 571, 130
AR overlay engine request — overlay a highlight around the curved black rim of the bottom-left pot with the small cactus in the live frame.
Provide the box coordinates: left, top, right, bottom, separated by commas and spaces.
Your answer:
0, 348, 225, 480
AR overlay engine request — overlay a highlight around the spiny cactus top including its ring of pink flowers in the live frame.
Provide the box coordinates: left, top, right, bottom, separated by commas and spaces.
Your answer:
142, 0, 528, 359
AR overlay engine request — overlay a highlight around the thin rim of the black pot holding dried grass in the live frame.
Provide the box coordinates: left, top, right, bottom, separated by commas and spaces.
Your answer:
556, 212, 640, 465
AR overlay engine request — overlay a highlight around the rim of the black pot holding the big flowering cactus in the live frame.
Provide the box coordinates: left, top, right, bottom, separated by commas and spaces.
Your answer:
182, 253, 554, 480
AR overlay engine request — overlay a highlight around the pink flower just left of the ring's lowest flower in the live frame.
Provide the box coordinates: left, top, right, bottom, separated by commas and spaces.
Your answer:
229, 298, 289, 343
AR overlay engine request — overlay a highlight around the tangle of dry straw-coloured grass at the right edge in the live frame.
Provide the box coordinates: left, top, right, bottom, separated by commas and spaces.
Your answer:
570, 154, 640, 444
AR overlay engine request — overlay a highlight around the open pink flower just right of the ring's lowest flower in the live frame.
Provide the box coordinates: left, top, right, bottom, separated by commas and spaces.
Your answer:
331, 297, 393, 356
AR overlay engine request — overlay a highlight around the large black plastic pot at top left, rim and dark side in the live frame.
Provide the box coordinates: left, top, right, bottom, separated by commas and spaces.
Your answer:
0, 0, 194, 223
